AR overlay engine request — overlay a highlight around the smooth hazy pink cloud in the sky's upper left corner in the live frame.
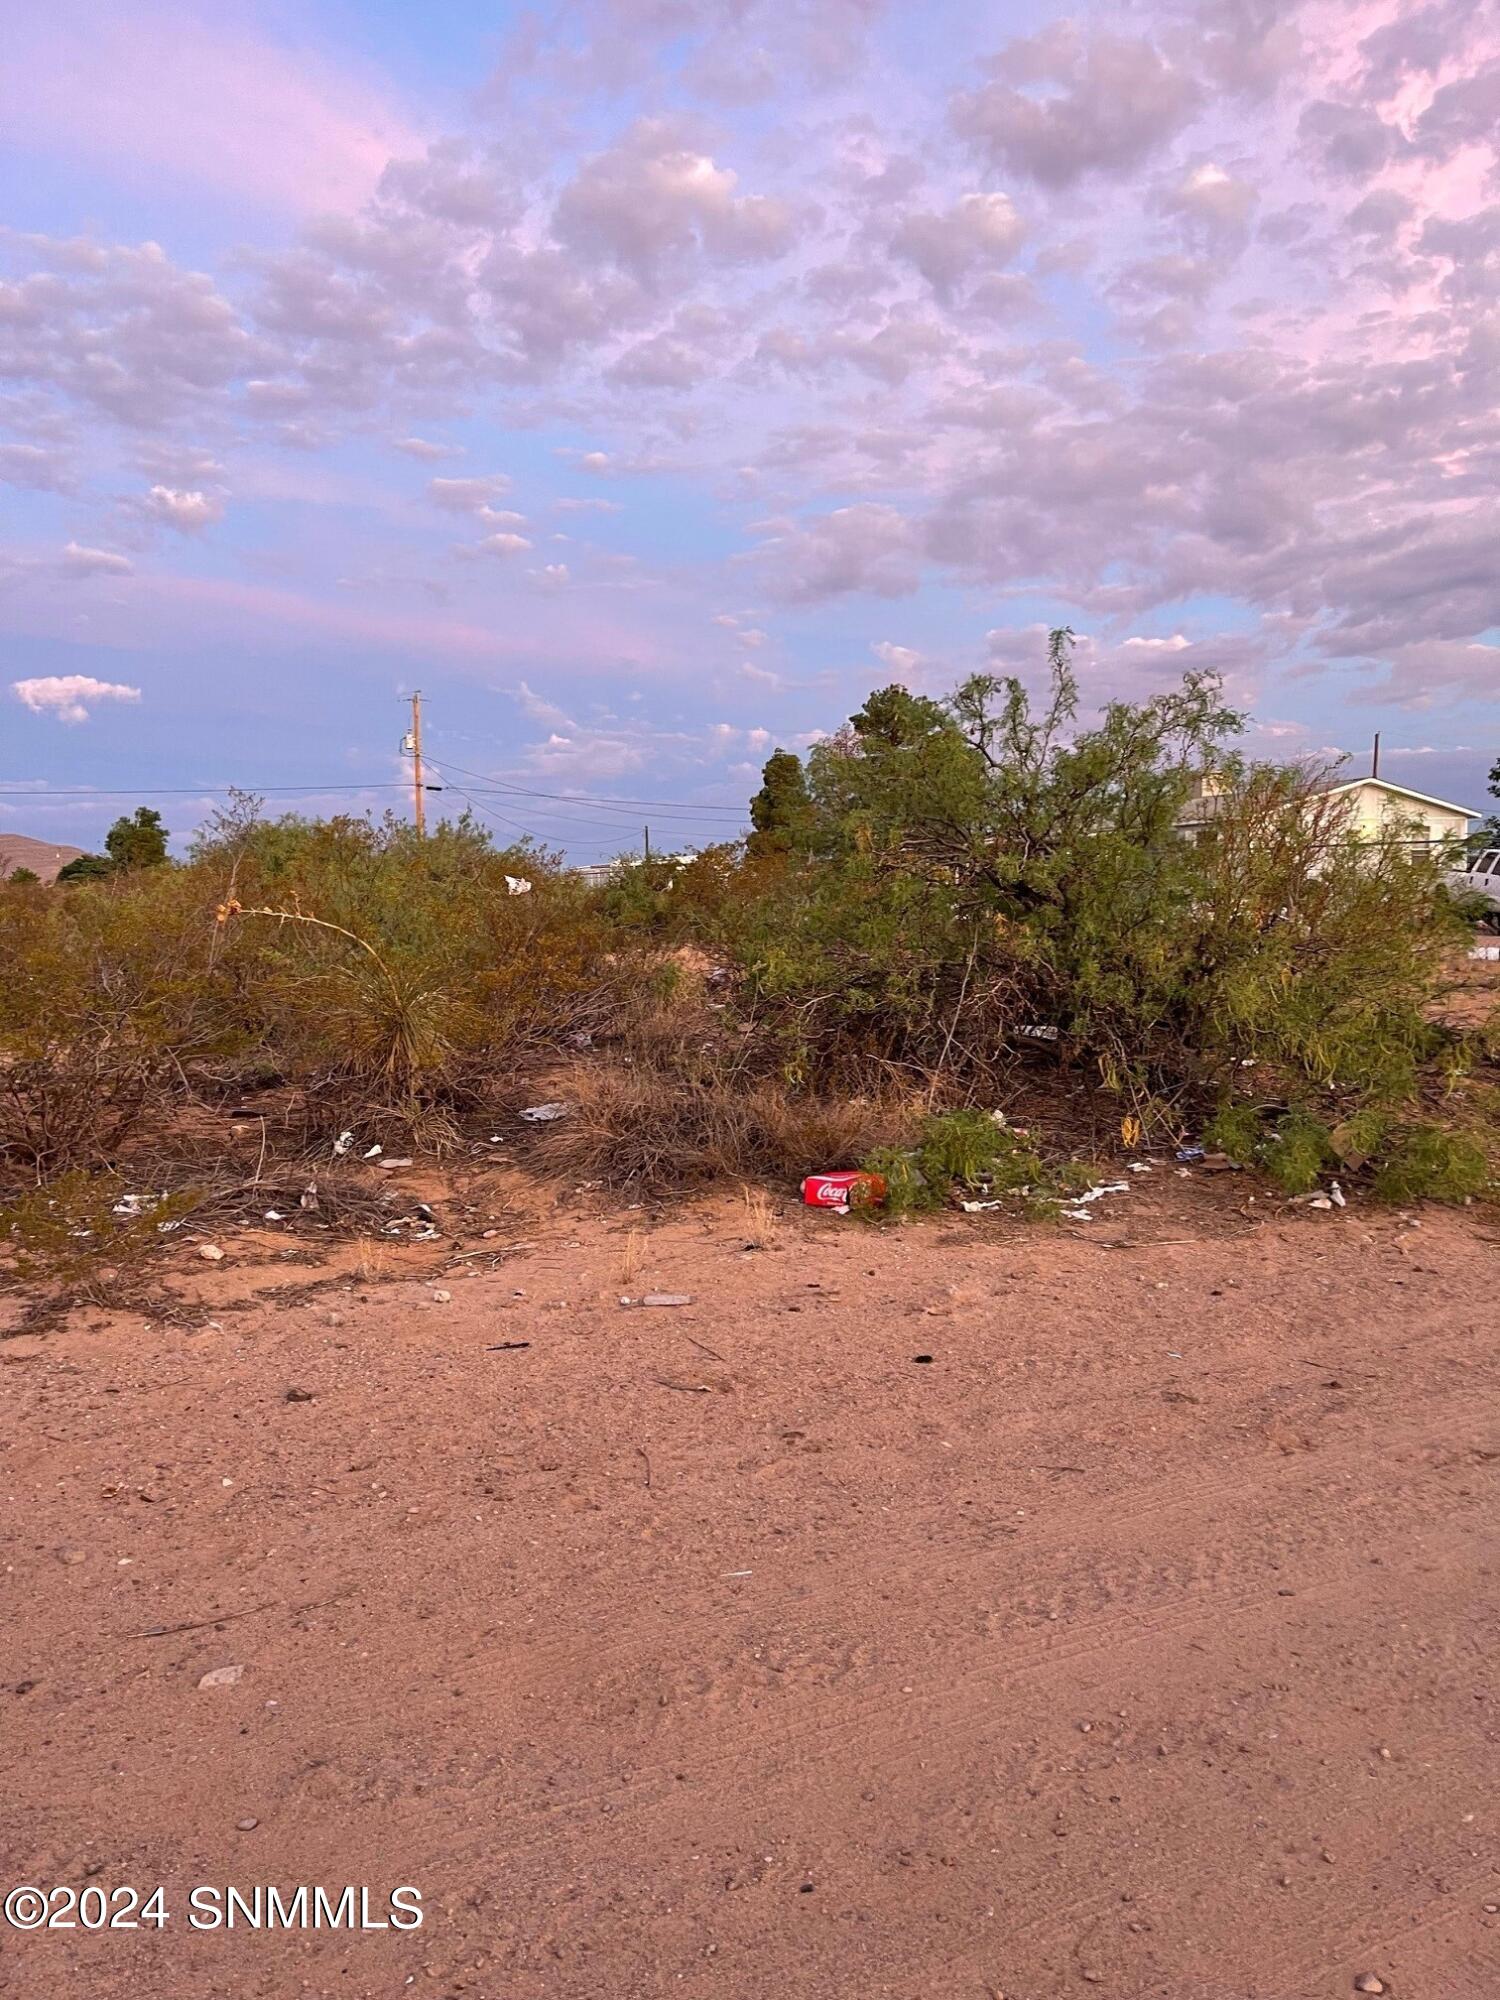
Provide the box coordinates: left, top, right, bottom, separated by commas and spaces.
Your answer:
0, 0, 422, 212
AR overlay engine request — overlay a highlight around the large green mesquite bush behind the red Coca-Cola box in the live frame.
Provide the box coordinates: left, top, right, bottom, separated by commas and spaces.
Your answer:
712, 632, 1456, 1132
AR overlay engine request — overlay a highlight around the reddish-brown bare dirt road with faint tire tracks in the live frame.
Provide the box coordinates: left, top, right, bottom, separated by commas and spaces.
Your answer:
0, 1166, 1500, 2000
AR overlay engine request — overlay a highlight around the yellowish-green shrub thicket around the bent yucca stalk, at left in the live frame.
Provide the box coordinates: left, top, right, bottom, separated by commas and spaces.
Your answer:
0, 800, 634, 1178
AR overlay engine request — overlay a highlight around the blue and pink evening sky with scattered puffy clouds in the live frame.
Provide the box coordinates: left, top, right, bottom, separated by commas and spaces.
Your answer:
0, 0, 1500, 862
